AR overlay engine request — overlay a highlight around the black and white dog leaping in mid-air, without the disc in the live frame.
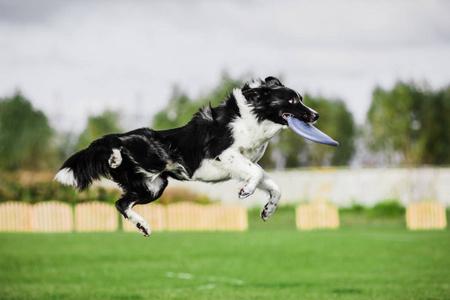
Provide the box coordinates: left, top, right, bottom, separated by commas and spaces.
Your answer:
55, 77, 319, 236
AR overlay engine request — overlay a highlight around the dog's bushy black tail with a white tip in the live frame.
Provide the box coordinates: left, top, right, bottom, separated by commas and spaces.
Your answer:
54, 137, 120, 190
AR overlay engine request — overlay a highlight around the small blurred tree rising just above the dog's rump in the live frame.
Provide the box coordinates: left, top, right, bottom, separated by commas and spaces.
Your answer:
76, 110, 121, 150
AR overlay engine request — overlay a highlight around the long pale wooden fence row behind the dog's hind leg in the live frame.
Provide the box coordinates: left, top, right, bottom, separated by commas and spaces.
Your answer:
0, 201, 248, 232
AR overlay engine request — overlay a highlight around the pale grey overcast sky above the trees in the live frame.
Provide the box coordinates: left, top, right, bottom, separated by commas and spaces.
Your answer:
0, 0, 450, 130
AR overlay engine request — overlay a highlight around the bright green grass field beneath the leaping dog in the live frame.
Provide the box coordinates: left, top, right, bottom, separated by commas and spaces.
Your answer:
0, 210, 450, 300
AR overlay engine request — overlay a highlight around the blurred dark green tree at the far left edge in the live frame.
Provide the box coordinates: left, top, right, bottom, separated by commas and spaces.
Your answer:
0, 92, 55, 170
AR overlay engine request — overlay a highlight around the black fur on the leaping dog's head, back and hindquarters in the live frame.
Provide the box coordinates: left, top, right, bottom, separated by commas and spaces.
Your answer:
56, 77, 318, 230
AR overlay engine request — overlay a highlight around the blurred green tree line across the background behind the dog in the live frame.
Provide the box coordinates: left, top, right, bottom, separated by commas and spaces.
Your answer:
0, 75, 450, 171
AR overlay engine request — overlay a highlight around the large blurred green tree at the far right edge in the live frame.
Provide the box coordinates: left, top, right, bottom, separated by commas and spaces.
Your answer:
367, 82, 450, 164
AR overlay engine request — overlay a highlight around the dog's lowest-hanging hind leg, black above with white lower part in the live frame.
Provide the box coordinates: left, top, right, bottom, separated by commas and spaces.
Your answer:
116, 176, 168, 236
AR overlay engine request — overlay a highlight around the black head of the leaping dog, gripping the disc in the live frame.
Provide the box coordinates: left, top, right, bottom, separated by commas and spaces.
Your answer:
242, 77, 319, 125
